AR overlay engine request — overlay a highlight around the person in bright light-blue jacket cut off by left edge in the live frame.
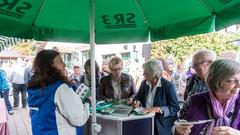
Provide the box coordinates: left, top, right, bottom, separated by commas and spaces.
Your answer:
0, 69, 13, 115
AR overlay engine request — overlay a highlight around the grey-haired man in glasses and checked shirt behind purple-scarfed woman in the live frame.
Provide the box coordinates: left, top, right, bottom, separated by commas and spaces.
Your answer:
184, 49, 217, 100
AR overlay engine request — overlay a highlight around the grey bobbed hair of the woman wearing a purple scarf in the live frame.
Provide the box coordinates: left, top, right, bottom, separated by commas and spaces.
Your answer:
206, 59, 240, 91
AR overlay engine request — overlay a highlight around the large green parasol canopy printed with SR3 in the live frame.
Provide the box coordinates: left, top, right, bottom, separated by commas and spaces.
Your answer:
0, 0, 240, 44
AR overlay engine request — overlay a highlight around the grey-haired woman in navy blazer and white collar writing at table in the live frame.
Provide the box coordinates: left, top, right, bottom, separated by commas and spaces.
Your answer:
133, 59, 179, 135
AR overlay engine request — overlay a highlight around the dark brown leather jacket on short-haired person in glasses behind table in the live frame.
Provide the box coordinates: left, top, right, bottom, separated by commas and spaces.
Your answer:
100, 73, 137, 99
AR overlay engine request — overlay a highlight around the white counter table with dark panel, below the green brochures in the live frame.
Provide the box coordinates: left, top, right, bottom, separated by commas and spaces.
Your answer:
85, 113, 155, 135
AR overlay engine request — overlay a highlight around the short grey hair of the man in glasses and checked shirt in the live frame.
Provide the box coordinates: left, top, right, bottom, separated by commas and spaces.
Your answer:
192, 49, 217, 61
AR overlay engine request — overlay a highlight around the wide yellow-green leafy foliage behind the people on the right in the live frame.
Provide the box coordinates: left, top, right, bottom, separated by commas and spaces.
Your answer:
152, 32, 240, 63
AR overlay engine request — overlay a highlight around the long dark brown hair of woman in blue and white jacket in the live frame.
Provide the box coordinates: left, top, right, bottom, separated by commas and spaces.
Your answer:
28, 50, 71, 88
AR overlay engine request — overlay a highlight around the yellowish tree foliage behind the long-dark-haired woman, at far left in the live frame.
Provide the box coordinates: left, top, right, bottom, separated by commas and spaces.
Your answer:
14, 41, 37, 56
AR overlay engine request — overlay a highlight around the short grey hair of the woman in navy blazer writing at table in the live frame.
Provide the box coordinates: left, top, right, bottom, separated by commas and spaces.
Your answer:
143, 59, 163, 77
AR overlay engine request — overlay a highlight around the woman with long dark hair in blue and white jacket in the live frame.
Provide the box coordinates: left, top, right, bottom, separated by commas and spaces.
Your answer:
28, 50, 89, 135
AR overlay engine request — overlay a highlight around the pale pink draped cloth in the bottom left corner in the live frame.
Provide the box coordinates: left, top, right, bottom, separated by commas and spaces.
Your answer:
0, 98, 10, 135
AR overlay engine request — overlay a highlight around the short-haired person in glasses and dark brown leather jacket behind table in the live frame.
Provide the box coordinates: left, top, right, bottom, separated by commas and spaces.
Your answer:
100, 56, 137, 104
